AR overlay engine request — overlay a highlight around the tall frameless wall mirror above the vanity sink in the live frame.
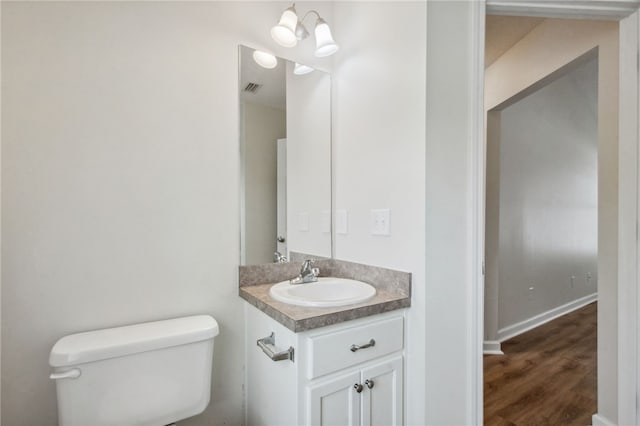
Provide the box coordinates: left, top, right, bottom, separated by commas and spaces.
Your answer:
239, 46, 331, 265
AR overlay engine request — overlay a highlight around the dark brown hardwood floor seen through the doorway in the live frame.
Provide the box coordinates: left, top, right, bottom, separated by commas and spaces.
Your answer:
484, 303, 597, 426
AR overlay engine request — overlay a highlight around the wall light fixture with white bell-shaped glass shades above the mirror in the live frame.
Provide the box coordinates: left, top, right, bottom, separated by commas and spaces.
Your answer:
271, 3, 338, 58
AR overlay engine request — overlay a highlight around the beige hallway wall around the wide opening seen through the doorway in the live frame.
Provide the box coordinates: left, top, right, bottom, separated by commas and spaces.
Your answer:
485, 19, 618, 423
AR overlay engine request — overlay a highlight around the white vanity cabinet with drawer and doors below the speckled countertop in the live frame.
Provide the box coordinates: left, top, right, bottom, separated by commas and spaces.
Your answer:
245, 304, 404, 426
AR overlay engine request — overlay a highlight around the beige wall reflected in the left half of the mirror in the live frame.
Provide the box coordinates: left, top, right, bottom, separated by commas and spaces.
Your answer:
241, 102, 287, 265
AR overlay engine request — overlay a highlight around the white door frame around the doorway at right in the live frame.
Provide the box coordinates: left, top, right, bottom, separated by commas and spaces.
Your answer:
468, 0, 640, 424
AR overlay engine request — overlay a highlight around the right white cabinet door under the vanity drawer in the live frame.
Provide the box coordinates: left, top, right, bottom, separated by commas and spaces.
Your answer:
362, 357, 403, 426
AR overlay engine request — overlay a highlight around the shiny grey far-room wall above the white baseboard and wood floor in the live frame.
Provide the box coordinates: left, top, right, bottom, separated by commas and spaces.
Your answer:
494, 58, 598, 329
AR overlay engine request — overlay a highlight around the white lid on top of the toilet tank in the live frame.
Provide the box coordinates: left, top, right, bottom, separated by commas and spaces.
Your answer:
49, 315, 219, 367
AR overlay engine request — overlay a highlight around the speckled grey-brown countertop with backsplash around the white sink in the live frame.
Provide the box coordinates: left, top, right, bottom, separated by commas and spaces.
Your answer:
239, 259, 411, 333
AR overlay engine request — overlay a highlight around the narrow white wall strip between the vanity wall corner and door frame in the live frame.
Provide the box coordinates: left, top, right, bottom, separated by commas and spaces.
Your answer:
419, 0, 482, 425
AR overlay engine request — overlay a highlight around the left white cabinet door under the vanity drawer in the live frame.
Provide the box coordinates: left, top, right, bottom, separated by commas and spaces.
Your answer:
307, 371, 364, 426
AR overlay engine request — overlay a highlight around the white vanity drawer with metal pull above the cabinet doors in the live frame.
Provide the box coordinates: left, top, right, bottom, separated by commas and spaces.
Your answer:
308, 316, 404, 379
